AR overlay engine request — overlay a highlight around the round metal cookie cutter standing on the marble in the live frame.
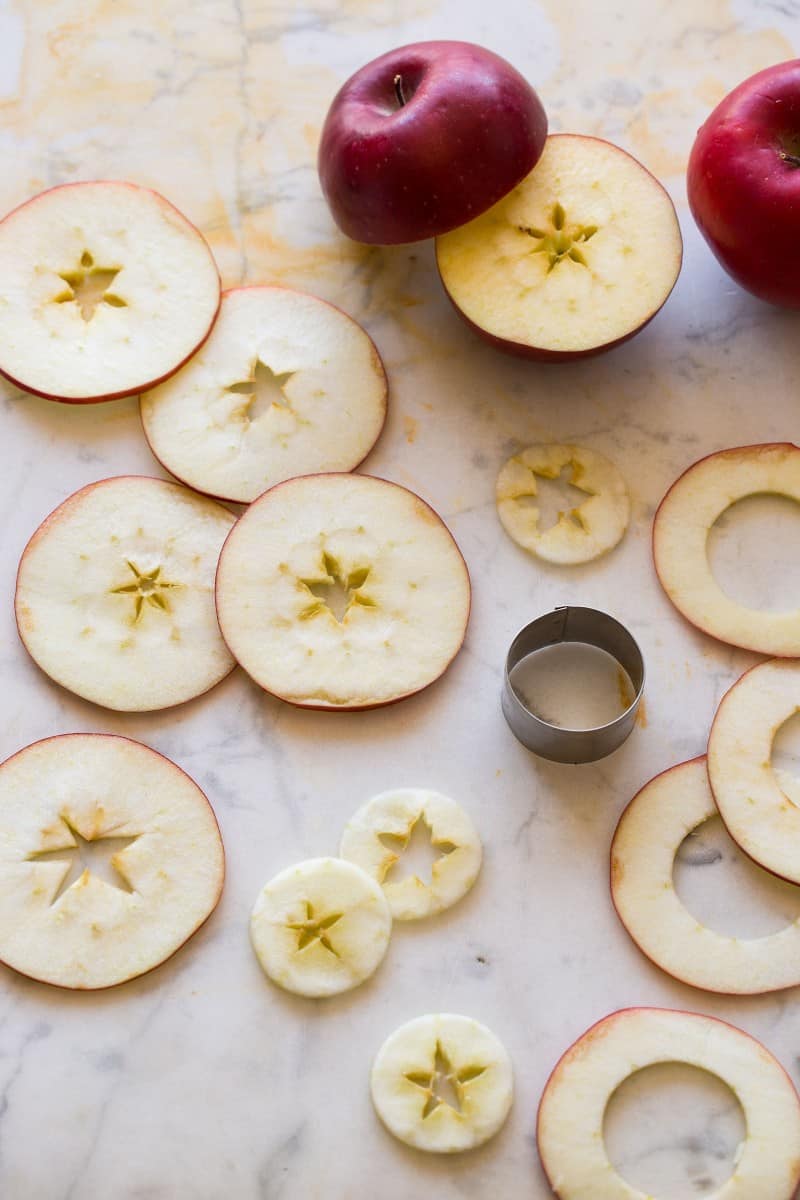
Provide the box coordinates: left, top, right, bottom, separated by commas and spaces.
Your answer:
503, 605, 644, 763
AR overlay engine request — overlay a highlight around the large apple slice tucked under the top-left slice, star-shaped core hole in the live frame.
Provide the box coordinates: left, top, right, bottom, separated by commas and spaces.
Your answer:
142, 287, 386, 503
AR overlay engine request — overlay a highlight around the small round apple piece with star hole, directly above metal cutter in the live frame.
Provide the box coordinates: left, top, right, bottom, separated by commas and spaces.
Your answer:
497, 445, 631, 564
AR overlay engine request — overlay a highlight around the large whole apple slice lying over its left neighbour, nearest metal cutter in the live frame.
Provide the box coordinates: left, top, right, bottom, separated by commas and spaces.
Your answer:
217, 474, 470, 709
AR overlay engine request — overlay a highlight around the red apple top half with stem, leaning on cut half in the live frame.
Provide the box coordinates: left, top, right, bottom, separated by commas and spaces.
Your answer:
318, 41, 547, 246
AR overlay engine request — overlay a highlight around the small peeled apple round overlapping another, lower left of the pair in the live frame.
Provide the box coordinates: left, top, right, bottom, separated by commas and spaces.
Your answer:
249, 858, 392, 996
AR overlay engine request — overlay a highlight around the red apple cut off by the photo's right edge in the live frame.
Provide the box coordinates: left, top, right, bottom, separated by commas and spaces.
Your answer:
687, 59, 800, 308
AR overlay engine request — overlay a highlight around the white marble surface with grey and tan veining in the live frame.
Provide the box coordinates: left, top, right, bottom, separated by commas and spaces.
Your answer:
0, 0, 800, 1200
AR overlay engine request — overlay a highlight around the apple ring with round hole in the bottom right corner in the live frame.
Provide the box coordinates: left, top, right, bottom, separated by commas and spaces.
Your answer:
536, 1008, 800, 1200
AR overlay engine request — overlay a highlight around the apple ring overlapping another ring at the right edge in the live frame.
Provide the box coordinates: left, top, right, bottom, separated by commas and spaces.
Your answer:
708, 659, 800, 883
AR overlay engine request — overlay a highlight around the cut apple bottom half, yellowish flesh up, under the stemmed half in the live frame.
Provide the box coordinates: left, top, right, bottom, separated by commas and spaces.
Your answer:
437, 133, 682, 359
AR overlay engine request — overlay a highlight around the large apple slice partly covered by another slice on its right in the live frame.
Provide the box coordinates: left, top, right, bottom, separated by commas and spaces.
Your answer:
16, 475, 234, 713
